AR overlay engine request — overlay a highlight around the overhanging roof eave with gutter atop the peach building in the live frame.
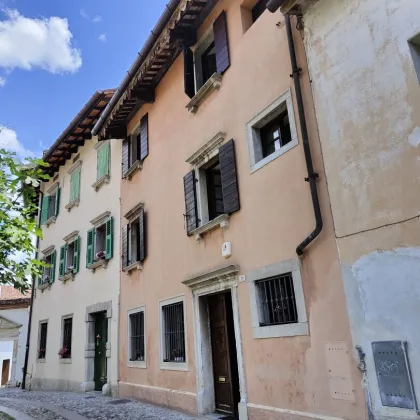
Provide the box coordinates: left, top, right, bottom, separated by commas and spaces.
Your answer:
92, 0, 218, 140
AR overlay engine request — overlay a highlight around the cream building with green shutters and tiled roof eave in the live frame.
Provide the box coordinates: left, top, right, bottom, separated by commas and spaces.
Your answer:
27, 90, 121, 394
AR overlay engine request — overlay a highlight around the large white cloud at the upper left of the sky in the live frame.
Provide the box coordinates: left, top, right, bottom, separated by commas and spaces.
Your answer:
0, 9, 82, 73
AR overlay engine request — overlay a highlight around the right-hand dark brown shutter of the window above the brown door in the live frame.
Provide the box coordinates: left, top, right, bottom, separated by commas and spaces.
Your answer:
219, 140, 241, 214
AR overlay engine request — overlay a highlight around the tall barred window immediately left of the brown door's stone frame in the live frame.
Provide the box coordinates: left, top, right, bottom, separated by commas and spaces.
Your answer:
162, 302, 185, 363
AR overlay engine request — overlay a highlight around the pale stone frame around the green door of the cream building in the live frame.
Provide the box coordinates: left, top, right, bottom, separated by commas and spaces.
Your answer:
82, 301, 112, 392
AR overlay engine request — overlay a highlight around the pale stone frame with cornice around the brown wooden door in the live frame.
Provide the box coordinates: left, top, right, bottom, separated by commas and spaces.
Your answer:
183, 265, 248, 420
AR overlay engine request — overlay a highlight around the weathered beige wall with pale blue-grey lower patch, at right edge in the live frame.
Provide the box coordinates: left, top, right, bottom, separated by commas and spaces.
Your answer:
303, 0, 420, 419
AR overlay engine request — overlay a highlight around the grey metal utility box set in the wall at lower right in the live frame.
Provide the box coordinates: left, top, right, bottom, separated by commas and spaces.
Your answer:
372, 341, 418, 412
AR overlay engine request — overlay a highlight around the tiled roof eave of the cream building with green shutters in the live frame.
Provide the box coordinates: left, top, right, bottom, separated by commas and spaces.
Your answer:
42, 89, 115, 175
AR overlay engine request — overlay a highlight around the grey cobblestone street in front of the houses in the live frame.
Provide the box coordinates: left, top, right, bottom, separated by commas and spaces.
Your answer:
0, 389, 204, 420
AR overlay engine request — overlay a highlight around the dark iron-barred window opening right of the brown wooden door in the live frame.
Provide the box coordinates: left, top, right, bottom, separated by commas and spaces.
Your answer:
256, 273, 298, 327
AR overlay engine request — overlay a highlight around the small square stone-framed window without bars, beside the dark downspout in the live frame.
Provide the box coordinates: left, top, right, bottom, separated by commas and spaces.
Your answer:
247, 90, 298, 172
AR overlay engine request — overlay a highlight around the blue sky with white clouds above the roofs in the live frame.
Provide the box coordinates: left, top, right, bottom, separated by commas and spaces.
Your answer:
0, 0, 166, 155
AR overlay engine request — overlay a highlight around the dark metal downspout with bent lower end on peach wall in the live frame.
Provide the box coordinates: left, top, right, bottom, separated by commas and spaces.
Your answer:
284, 15, 323, 256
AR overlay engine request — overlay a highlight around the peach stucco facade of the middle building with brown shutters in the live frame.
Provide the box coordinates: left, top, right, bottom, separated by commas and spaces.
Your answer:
113, 0, 365, 420
